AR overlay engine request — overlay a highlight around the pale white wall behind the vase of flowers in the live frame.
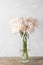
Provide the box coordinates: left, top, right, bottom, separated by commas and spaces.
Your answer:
0, 0, 43, 57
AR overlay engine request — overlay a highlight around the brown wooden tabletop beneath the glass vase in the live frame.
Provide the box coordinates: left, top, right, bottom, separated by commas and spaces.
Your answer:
0, 57, 43, 65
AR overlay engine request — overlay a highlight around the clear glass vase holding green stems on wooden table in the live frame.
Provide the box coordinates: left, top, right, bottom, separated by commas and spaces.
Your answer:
20, 34, 29, 63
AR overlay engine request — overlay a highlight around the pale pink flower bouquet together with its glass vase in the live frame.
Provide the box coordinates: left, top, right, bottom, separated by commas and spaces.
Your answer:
10, 17, 39, 62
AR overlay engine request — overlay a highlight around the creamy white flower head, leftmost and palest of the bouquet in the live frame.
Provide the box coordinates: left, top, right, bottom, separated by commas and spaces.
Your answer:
10, 18, 21, 33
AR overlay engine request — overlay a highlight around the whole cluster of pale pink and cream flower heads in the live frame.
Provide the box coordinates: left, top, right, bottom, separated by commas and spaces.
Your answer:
10, 17, 38, 33
